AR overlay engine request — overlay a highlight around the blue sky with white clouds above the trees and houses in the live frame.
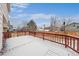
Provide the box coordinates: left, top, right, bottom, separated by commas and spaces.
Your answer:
9, 3, 79, 27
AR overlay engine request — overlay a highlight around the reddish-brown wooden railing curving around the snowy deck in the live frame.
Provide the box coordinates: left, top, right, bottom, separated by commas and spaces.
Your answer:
3, 32, 79, 53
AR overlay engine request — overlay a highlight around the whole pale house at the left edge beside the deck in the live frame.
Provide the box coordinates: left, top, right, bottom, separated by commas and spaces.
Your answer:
0, 3, 10, 51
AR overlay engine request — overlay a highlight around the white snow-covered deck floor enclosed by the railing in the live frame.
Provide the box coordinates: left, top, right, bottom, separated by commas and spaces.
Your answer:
4, 36, 78, 56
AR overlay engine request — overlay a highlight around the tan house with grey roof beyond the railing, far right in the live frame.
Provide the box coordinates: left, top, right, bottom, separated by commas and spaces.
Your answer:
65, 22, 79, 32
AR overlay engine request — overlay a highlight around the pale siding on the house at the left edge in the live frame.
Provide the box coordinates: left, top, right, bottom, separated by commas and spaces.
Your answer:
0, 3, 9, 51
